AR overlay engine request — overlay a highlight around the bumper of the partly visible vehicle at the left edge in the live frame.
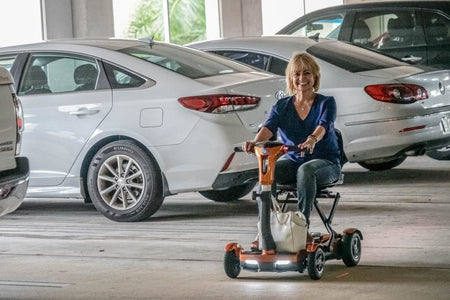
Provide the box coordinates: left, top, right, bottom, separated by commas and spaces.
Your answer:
0, 157, 30, 216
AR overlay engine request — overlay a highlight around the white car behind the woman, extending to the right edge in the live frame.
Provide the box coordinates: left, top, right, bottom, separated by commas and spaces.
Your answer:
189, 35, 450, 170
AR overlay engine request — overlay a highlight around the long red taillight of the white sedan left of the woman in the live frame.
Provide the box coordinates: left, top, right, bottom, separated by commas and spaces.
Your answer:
178, 95, 261, 114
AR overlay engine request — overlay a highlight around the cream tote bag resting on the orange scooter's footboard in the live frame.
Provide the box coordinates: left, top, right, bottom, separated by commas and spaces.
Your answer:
258, 197, 308, 253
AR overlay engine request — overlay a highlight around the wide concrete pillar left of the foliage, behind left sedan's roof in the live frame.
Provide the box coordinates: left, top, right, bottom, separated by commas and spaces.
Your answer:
41, 0, 114, 39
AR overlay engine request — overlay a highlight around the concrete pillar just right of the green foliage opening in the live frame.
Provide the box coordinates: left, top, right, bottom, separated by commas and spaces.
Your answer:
219, 0, 262, 38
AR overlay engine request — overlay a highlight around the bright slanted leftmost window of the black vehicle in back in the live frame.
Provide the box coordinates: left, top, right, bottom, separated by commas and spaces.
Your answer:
286, 13, 345, 39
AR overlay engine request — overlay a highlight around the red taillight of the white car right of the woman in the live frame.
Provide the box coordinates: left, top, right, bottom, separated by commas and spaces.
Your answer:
364, 83, 428, 104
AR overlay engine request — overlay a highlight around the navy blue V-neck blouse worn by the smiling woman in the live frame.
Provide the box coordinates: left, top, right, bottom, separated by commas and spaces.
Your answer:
263, 94, 340, 165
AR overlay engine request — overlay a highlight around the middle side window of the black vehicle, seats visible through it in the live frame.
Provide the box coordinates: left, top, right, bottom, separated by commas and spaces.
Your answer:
351, 9, 425, 49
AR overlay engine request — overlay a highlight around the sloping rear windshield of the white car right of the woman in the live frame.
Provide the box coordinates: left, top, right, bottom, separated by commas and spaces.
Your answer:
306, 42, 408, 73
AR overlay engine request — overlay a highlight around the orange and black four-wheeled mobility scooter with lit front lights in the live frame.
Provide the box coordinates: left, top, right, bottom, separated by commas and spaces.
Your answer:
224, 141, 362, 280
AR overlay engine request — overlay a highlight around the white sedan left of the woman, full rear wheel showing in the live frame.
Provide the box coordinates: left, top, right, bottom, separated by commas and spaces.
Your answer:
0, 39, 285, 221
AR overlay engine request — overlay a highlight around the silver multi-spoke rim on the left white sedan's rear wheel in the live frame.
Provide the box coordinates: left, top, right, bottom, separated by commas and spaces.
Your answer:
97, 155, 146, 210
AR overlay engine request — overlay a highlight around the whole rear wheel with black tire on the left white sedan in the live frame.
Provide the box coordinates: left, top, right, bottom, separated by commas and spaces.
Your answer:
87, 141, 164, 222
